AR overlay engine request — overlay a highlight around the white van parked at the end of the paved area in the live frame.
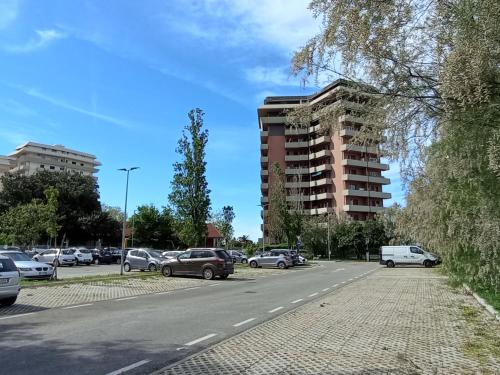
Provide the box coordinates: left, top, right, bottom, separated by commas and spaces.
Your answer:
380, 245, 439, 268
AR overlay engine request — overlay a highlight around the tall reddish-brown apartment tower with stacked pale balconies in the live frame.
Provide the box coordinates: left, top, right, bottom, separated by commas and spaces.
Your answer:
258, 80, 391, 236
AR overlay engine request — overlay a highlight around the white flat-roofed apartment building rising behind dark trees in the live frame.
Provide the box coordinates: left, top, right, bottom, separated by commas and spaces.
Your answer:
0, 142, 101, 176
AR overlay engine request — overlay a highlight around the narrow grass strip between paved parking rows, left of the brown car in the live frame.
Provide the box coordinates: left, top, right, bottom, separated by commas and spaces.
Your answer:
21, 272, 160, 288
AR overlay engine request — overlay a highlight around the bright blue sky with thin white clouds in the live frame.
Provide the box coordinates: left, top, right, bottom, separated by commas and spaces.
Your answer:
0, 0, 403, 240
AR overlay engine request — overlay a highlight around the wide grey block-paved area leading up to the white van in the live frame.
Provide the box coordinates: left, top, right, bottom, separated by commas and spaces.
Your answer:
158, 268, 500, 375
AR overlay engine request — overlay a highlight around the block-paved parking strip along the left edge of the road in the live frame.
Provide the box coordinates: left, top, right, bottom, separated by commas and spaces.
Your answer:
0, 267, 286, 317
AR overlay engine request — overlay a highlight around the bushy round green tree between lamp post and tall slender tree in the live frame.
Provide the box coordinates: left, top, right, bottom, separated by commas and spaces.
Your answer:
129, 204, 177, 249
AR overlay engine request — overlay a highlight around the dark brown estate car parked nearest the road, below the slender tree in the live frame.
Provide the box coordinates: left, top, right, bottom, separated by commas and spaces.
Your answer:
161, 248, 234, 280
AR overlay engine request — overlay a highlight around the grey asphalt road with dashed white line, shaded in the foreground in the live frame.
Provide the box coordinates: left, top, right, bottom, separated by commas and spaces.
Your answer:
0, 262, 379, 375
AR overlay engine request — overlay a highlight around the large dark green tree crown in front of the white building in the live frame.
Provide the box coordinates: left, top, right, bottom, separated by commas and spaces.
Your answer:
0, 171, 101, 243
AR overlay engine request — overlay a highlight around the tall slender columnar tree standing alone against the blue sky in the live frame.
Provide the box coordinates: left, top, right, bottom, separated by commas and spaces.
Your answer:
168, 108, 210, 246
